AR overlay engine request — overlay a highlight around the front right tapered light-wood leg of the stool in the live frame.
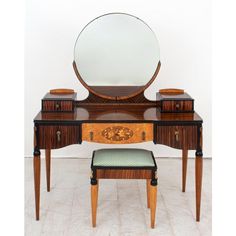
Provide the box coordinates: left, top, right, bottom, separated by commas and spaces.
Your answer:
149, 180, 157, 228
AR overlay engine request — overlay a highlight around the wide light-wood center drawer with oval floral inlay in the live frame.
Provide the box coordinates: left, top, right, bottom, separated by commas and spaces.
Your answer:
82, 123, 153, 144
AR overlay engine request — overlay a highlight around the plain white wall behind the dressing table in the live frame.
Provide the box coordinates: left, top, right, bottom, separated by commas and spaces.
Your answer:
24, 0, 212, 157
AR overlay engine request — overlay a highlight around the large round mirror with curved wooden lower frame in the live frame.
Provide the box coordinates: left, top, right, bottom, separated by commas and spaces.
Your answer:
73, 13, 160, 100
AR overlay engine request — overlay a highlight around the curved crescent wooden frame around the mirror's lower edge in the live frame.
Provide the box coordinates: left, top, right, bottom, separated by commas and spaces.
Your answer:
73, 61, 161, 101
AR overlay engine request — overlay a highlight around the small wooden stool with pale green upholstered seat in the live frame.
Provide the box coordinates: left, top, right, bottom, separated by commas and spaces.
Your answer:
91, 148, 157, 228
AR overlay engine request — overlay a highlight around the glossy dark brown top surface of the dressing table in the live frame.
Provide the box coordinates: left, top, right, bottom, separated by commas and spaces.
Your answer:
34, 105, 202, 123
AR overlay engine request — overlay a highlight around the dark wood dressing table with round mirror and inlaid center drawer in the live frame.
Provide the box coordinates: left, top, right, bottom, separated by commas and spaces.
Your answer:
33, 13, 203, 221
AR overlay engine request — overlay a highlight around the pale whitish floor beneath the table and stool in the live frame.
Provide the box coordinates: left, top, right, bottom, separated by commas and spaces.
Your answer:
25, 158, 212, 236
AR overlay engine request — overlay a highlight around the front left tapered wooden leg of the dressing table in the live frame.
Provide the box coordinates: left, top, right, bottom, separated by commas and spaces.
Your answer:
33, 149, 40, 220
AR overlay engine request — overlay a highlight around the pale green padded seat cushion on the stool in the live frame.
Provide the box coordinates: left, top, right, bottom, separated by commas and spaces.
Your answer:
93, 148, 156, 167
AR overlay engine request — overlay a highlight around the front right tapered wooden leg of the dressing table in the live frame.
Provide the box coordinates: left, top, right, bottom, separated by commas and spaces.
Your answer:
195, 151, 203, 221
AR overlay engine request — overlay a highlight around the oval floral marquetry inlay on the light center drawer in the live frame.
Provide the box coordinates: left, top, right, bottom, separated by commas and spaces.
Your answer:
102, 126, 134, 141
